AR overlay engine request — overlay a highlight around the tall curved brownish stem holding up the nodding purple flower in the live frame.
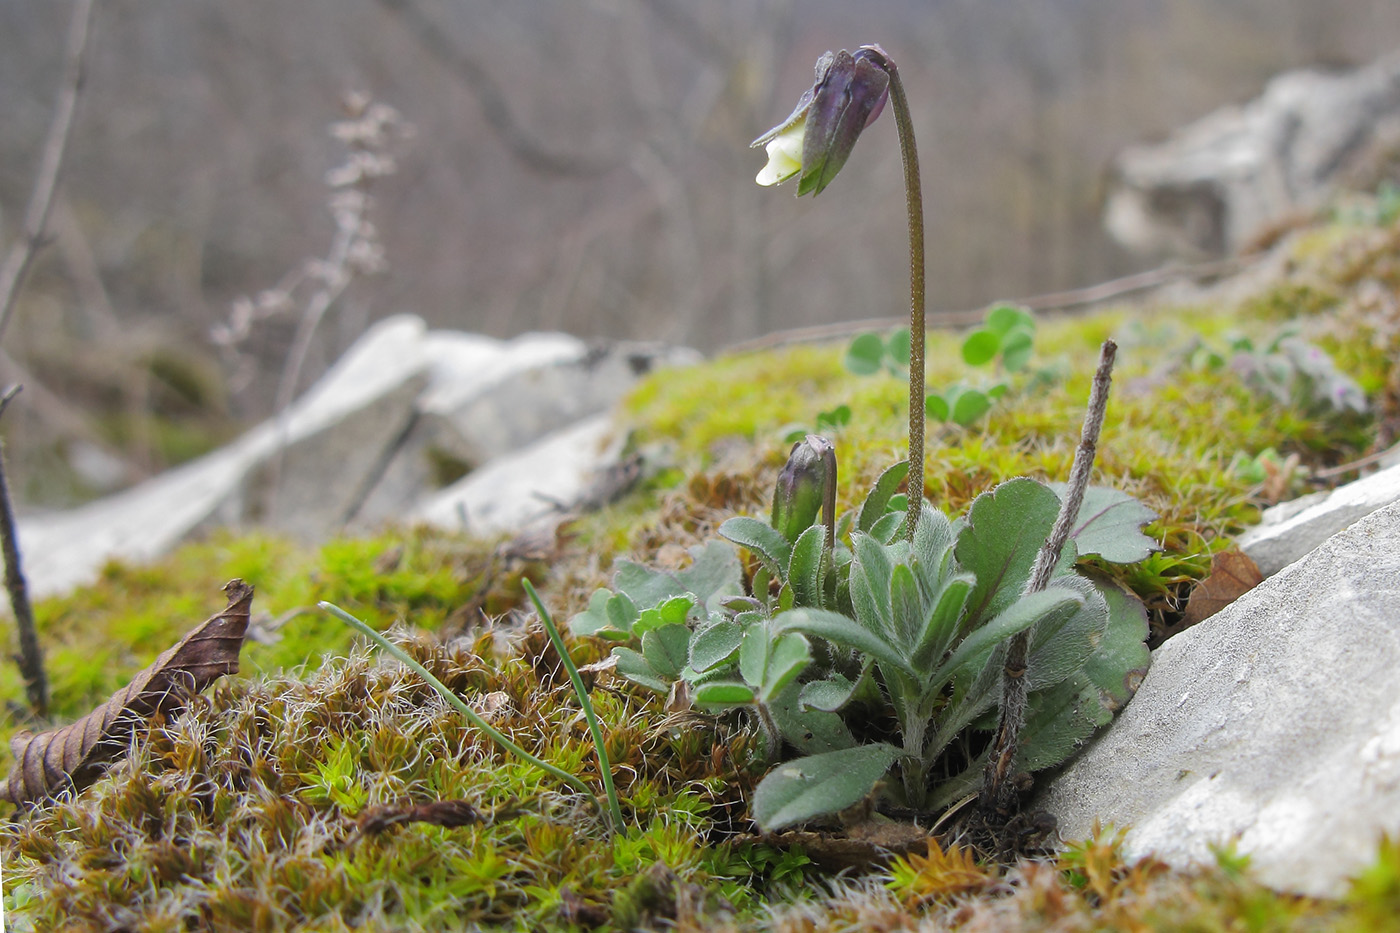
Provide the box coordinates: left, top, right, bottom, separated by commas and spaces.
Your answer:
885, 56, 924, 541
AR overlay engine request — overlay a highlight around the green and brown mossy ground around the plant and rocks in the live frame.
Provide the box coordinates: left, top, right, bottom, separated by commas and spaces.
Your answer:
8, 214, 1400, 932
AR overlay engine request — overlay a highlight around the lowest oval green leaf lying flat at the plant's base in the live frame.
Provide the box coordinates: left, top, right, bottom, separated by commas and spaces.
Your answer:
753, 742, 900, 832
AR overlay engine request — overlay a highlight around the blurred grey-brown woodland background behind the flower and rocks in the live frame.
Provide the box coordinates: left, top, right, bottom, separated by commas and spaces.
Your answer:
8, 0, 1400, 504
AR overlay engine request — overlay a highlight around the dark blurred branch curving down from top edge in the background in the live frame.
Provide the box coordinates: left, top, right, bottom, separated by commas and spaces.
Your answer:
378, 0, 617, 177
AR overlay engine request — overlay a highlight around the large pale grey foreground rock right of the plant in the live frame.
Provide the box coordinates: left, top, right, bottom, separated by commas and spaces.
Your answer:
1037, 503, 1400, 895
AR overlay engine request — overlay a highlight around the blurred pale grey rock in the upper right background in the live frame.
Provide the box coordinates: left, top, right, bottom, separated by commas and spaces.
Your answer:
1105, 53, 1400, 259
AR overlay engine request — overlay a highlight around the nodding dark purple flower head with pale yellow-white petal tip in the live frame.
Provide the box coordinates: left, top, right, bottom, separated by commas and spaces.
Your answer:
752, 45, 895, 196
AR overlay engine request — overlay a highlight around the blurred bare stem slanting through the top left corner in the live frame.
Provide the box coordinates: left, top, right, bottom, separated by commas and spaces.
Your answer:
0, 0, 94, 341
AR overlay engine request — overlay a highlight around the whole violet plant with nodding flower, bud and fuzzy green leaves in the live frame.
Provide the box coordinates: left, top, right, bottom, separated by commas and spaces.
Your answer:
570, 45, 1155, 831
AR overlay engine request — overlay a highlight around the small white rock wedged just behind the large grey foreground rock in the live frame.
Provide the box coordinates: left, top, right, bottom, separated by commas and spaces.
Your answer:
1239, 467, 1400, 577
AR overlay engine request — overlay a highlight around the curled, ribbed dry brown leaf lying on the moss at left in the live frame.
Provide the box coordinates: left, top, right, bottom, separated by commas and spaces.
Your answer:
0, 580, 253, 804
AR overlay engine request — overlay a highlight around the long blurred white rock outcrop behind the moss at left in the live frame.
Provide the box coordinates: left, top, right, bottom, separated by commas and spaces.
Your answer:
20, 315, 699, 595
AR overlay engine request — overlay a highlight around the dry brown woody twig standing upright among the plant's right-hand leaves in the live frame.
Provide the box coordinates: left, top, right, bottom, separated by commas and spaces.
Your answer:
980, 340, 1119, 817
